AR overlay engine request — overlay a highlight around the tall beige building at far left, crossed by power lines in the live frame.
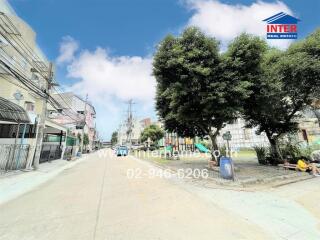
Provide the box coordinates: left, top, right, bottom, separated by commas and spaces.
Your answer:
0, 0, 66, 172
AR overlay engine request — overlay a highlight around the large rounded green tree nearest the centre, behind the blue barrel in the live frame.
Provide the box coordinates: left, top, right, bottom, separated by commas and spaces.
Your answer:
153, 27, 249, 157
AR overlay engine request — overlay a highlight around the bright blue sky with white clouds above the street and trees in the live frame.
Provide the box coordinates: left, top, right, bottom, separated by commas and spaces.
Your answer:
9, 0, 320, 140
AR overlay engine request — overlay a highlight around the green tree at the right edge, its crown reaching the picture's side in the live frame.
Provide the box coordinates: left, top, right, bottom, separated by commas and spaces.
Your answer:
244, 30, 320, 159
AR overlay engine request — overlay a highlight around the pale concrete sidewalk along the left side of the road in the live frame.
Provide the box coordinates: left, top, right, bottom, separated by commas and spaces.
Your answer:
0, 154, 88, 205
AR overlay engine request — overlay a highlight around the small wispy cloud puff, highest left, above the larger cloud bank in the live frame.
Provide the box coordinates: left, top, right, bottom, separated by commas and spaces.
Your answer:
57, 36, 79, 64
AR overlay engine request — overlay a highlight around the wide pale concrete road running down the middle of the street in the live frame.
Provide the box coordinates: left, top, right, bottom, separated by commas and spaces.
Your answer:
0, 150, 272, 240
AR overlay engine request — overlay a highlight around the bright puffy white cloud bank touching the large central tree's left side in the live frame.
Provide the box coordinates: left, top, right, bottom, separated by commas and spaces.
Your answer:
68, 48, 155, 102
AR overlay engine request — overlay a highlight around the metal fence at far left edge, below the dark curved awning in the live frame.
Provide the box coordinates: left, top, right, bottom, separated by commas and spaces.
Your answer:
0, 144, 30, 172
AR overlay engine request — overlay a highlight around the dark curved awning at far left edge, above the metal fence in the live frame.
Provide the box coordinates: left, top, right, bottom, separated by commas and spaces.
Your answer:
0, 97, 30, 123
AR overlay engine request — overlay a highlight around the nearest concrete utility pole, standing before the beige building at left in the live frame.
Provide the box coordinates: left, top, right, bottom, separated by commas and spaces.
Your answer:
33, 62, 53, 170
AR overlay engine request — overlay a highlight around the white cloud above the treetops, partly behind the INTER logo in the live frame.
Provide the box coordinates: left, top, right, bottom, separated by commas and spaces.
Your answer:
186, 0, 292, 48
